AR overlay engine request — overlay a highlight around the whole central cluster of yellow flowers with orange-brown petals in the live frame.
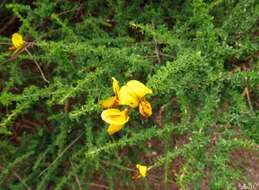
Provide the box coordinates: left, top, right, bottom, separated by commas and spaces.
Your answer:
101, 78, 152, 135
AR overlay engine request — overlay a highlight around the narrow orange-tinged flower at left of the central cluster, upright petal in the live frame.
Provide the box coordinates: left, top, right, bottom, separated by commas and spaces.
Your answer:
101, 77, 120, 108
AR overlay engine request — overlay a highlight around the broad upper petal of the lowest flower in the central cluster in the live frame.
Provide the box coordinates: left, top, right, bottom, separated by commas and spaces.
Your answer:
101, 109, 129, 125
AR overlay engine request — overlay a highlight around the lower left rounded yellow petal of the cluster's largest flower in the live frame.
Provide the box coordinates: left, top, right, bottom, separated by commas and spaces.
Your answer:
119, 86, 139, 108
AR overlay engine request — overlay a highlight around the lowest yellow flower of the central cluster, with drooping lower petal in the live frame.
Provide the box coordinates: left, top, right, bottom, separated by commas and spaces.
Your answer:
101, 109, 129, 135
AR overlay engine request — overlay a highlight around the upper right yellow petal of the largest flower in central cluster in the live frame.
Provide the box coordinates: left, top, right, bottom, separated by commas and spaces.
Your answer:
126, 80, 152, 99
